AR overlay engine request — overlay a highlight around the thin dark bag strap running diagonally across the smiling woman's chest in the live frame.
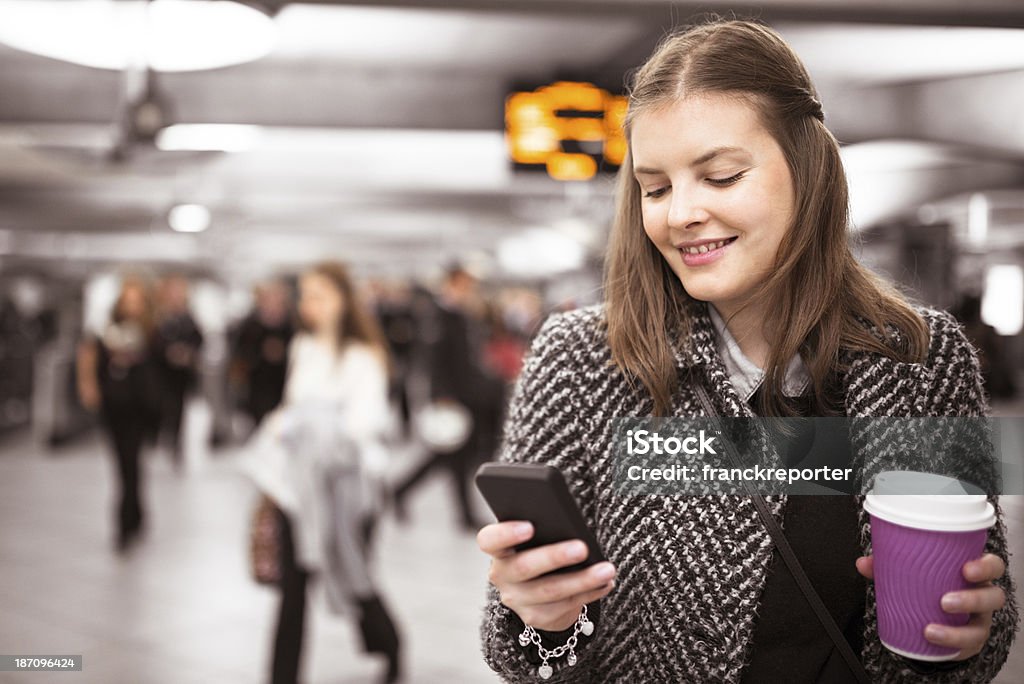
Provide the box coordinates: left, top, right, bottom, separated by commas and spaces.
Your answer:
694, 382, 871, 684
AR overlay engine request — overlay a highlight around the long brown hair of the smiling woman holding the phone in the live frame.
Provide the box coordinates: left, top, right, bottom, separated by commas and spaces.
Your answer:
605, 19, 929, 416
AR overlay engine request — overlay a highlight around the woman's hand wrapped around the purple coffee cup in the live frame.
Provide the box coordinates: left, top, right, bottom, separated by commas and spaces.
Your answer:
857, 553, 1007, 660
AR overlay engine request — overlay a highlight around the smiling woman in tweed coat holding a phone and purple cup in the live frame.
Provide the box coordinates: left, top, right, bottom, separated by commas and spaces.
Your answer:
478, 20, 1018, 684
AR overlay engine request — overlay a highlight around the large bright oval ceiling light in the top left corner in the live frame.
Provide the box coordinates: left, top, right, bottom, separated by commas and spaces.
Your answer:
0, 0, 274, 72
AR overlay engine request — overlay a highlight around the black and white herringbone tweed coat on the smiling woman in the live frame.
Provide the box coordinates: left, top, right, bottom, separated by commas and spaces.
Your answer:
481, 306, 1018, 684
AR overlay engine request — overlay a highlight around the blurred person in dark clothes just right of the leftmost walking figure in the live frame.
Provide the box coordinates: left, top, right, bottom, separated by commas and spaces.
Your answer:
156, 274, 203, 470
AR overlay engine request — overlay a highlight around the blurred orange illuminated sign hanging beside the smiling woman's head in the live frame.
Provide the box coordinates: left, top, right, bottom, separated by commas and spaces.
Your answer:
505, 81, 627, 180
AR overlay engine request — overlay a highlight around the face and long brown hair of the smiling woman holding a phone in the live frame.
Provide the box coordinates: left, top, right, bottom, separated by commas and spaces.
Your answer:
606, 20, 928, 416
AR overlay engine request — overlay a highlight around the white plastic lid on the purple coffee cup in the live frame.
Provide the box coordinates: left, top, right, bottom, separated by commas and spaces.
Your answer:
864, 470, 995, 531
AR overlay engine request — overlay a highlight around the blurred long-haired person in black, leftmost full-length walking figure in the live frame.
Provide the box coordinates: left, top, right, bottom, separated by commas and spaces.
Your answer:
77, 277, 161, 552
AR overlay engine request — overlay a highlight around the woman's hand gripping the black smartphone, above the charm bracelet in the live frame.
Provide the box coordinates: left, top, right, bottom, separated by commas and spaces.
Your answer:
476, 521, 615, 632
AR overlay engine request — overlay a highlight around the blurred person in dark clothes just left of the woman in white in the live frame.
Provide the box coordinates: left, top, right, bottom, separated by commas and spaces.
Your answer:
231, 281, 295, 425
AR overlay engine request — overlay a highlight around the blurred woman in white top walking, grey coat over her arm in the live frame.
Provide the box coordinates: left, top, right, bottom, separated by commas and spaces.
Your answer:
244, 262, 400, 684
